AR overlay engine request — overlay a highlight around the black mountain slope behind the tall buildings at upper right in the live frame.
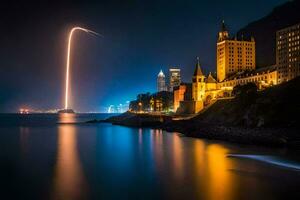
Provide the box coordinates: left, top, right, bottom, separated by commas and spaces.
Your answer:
237, 0, 300, 67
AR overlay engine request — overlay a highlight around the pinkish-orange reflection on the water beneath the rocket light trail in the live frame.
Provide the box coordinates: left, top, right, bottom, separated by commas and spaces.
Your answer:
53, 114, 86, 199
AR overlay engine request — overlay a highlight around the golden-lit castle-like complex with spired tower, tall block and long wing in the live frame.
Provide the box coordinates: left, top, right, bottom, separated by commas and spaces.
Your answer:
174, 22, 278, 114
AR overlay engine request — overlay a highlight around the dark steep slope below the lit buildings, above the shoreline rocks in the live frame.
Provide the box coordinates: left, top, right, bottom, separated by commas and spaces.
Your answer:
193, 77, 300, 128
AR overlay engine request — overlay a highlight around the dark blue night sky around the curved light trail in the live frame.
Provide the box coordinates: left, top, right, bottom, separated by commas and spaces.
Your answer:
0, 0, 286, 112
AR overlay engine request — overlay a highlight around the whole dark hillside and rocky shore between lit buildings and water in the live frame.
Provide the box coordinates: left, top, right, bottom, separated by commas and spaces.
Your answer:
101, 77, 300, 149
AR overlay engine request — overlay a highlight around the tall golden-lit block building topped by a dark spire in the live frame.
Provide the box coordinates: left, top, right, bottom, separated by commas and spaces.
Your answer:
217, 21, 256, 82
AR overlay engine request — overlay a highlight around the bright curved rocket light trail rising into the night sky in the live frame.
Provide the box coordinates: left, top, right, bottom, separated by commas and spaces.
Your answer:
65, 27, 101, 109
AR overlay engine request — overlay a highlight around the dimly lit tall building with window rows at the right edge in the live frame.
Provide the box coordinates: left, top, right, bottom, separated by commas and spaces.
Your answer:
276, 24, 300, 84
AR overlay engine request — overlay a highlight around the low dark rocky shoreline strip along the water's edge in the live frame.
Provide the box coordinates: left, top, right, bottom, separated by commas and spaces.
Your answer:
85, 113, 300, 149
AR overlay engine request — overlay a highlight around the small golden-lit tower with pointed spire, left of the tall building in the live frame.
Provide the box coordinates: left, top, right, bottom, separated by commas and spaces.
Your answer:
192, 57, 205, 101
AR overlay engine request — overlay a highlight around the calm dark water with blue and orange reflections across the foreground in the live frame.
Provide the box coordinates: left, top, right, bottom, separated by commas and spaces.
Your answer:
0, 114, 300, 200
